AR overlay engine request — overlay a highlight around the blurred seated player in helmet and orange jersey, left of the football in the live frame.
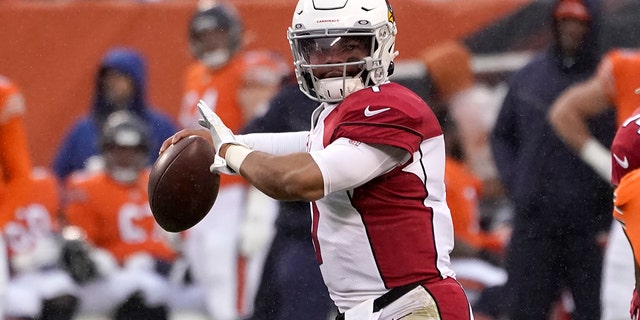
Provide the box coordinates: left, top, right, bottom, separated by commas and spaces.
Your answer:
64, 110, 181, 320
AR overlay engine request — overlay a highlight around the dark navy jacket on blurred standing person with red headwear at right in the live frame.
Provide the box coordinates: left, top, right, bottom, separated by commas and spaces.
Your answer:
490, 1, 615, 232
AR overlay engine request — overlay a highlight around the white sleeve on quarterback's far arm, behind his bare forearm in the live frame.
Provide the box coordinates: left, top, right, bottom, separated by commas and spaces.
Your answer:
236, 131, 309, 155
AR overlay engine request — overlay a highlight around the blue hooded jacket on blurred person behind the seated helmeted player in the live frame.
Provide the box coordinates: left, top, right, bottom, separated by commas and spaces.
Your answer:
53, 48, 177, 179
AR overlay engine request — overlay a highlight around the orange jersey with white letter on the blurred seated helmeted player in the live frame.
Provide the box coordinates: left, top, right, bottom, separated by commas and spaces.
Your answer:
65, 172, 175, 263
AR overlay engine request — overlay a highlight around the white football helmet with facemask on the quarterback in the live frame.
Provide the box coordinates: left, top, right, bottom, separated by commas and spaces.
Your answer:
287, 0, 398, 102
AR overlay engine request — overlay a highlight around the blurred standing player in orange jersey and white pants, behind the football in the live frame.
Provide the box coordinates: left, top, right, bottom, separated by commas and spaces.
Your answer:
179, 1, 287, 320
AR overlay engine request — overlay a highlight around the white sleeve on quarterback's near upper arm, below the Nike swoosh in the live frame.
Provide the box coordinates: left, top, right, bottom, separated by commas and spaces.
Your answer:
310, 138, 410, 195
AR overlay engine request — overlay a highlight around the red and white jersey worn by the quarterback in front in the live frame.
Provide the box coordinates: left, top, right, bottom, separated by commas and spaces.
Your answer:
308, 83, 455, 310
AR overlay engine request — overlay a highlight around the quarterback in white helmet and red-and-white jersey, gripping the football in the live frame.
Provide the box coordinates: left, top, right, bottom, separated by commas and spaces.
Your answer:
161, 0, 472, 320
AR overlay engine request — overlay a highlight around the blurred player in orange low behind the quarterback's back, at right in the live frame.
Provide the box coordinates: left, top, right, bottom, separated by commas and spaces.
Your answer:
436, 107, 511, 310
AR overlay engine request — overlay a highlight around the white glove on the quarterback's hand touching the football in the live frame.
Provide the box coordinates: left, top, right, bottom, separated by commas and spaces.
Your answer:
198, 100, 249, 175
